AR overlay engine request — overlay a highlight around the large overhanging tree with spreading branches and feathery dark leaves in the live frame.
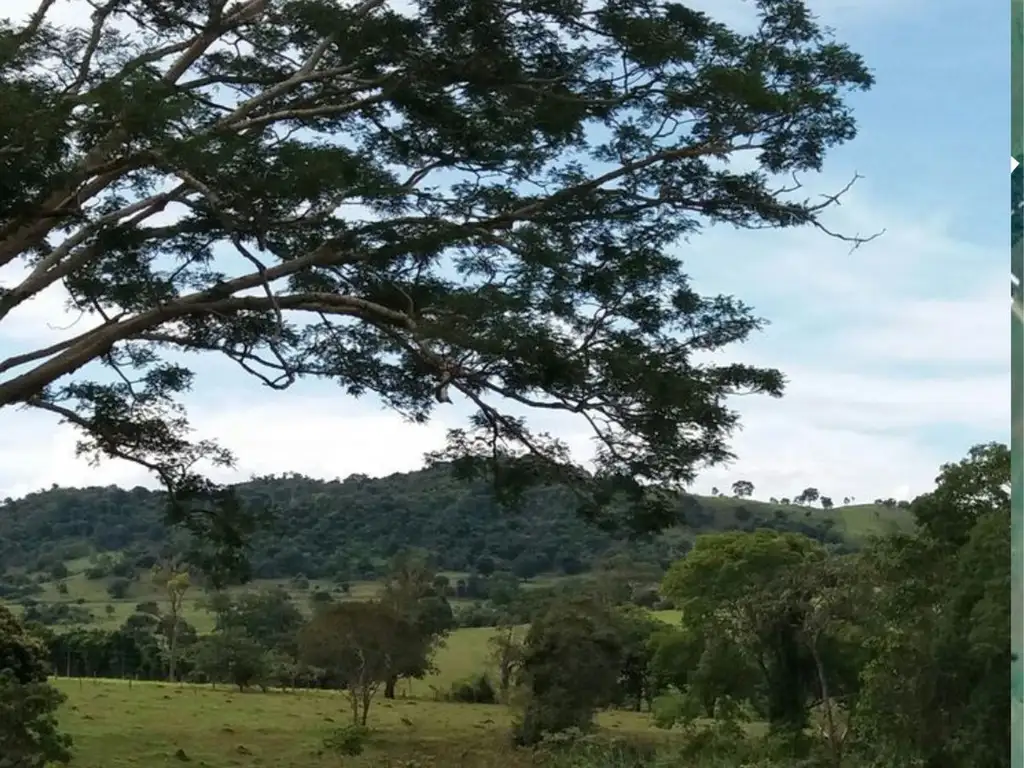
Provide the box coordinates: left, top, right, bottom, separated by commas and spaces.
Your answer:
0, 0, 871, 552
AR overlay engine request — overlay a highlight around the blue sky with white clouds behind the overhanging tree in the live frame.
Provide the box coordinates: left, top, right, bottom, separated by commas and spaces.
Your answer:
0, 0, 1010, 501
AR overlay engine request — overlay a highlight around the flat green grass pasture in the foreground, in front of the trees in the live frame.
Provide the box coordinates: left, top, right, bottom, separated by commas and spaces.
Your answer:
57, 680, 668, 768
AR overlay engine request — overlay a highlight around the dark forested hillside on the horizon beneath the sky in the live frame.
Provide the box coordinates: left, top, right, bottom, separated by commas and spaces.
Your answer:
0, 469, 906, 579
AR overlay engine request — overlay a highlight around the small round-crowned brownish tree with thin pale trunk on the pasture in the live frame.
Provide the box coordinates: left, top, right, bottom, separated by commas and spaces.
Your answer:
298, 601, 417, 726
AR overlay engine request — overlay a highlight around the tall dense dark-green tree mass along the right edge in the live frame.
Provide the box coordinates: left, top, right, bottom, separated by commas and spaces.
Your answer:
856, 444, 1011, 768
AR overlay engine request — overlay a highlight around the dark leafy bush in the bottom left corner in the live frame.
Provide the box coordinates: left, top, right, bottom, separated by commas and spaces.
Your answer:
0, 606, 71, 768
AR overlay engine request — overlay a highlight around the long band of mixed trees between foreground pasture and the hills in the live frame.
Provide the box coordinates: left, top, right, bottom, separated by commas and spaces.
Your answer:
4, 443, 1011, 768
